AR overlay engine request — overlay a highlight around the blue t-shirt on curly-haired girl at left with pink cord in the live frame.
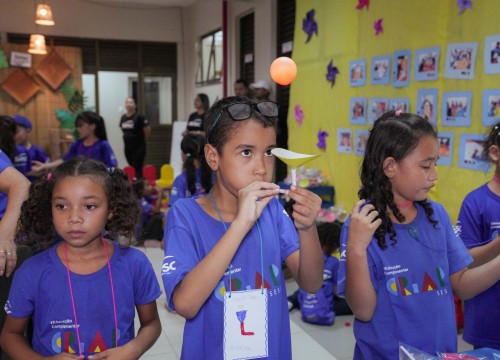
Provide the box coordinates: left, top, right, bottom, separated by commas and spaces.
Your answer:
5, 243, 161, 358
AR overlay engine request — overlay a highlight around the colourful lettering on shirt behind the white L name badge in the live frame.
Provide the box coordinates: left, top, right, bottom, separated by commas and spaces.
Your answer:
214, 264, 281, 302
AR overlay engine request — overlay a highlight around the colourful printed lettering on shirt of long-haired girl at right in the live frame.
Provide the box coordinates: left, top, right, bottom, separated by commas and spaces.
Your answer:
384, 265, 448, 297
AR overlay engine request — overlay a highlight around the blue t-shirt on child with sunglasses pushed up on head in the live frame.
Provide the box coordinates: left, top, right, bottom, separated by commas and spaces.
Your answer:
162, 198, 299, 360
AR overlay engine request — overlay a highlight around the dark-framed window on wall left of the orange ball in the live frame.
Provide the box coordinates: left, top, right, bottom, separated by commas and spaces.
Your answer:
196, 29, 222, 85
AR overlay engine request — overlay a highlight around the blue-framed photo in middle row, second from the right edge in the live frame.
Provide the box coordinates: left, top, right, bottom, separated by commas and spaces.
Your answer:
441, 91, 472, 126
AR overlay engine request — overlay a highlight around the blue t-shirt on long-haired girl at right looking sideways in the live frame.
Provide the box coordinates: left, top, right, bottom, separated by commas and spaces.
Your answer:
338, 201, 472, 360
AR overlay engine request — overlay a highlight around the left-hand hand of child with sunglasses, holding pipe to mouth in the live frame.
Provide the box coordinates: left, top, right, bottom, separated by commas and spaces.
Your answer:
235, 181, 279, 226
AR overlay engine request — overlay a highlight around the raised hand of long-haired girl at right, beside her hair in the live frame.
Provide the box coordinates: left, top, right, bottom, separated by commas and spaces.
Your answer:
347, 200, 382, 250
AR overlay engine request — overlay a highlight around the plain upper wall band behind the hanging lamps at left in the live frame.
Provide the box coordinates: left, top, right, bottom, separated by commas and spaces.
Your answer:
0, 0, 182, 42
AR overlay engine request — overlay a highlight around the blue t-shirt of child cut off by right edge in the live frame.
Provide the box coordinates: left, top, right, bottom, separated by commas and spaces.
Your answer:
457, 184, 500, 350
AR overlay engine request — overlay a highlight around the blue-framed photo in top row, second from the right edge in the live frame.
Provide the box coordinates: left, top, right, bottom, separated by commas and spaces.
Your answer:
444, 43, 477, 79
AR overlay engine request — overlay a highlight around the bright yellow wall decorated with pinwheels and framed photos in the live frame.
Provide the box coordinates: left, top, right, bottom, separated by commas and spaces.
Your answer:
288, 0, 500, 221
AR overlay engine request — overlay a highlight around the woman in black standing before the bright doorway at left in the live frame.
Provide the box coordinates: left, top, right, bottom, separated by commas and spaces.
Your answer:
120, 96, 151, 178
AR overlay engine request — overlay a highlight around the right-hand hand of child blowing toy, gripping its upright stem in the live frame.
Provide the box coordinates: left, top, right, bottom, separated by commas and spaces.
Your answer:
287, 185, 321, 230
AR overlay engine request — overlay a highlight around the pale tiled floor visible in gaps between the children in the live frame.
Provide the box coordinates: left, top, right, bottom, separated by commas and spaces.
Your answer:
136, 247, 471, 360
